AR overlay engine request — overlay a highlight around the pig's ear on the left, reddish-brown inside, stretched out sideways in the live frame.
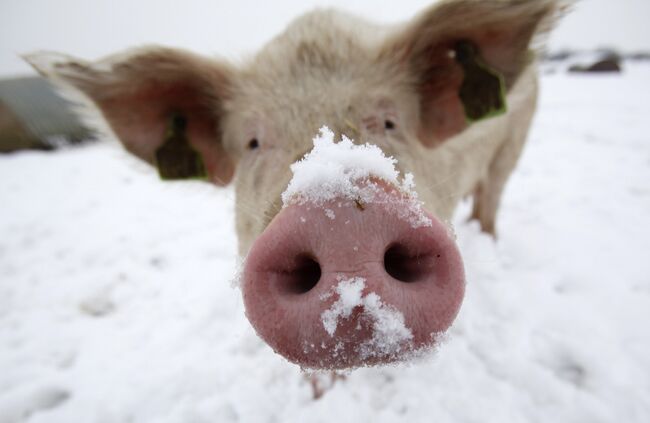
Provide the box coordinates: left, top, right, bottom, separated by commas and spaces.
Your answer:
24, 47, 234, 185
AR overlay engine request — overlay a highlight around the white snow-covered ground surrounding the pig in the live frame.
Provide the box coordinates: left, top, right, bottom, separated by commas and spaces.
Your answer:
0, 64, 650, 423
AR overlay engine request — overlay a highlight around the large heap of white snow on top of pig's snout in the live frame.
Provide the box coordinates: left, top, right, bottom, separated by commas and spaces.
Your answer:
282, 126, 431, 227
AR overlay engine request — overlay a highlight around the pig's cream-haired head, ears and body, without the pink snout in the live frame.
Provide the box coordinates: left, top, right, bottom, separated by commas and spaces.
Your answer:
26, 0, 561, 372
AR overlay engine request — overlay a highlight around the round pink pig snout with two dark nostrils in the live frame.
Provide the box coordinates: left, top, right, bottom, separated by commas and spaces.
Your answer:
242, 184, 465, 369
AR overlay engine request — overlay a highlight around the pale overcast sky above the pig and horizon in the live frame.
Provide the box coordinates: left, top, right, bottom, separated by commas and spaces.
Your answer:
0, 0, 650, 76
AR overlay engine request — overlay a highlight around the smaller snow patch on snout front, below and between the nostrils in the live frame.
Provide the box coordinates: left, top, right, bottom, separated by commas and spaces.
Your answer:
321, 276, 413, 359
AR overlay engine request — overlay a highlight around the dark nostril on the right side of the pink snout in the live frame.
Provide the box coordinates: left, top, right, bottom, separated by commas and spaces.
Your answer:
384, 244, 434, 282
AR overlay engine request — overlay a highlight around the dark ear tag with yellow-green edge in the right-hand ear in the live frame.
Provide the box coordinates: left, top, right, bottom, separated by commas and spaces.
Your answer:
454, 40, 507, 123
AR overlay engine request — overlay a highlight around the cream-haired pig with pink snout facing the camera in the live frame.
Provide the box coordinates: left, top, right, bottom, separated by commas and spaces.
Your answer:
26, 0, 565, 369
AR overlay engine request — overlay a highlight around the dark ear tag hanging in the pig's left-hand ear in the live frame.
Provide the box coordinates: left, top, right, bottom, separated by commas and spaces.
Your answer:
156, 114, 208, 180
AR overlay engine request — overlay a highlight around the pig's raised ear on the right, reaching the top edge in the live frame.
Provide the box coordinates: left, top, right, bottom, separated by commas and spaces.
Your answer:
381, 0, 561, 147
